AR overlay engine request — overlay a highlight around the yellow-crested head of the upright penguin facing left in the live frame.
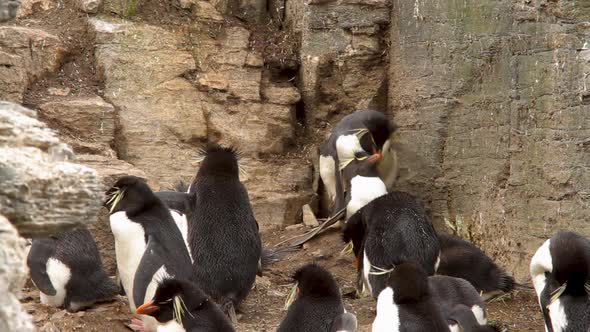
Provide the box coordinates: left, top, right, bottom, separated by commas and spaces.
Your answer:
104, 175, 158, 215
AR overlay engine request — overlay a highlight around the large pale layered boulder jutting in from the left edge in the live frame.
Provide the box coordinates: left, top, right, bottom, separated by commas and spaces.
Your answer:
0, 102, 103, 237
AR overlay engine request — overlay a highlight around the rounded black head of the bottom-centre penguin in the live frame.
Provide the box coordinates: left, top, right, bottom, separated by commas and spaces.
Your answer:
293, 263, 340, 297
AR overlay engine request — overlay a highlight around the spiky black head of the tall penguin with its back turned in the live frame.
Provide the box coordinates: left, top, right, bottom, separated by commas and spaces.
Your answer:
191, 143, 240, 179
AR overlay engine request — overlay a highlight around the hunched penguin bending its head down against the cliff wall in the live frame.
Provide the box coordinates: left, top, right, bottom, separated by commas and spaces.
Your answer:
319, 110, 397, 215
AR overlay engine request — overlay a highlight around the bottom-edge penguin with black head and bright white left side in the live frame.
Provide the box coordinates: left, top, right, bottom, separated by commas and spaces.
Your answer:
372, 262, 449, 332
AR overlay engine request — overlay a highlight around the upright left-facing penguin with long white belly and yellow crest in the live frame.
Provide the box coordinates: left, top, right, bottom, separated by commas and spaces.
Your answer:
105, 176, 193, 330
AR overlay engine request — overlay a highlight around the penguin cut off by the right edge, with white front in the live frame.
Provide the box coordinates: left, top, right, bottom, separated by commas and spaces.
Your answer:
530, 231, 590, 332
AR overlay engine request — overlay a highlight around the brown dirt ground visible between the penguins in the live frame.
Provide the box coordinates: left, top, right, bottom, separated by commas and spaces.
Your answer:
23, 227, 543, 332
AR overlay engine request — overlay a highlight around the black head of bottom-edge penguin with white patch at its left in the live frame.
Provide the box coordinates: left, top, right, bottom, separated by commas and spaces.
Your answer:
387, 262, 429, 304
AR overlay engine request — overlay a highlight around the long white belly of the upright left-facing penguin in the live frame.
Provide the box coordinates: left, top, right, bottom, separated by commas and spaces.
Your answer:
109, 211, 146, 311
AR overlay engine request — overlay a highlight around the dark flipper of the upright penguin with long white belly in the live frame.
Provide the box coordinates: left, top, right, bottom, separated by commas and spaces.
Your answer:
133, 236, 164, 306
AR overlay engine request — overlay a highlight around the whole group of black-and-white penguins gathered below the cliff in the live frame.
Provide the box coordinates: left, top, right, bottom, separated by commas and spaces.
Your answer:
27, 110, 590, 332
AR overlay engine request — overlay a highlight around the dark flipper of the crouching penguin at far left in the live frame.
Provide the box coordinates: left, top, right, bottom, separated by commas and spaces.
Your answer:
27, 238, 57, 296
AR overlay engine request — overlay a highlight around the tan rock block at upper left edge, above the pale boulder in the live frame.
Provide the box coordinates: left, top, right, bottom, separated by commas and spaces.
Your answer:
0, 26, 65, 102
